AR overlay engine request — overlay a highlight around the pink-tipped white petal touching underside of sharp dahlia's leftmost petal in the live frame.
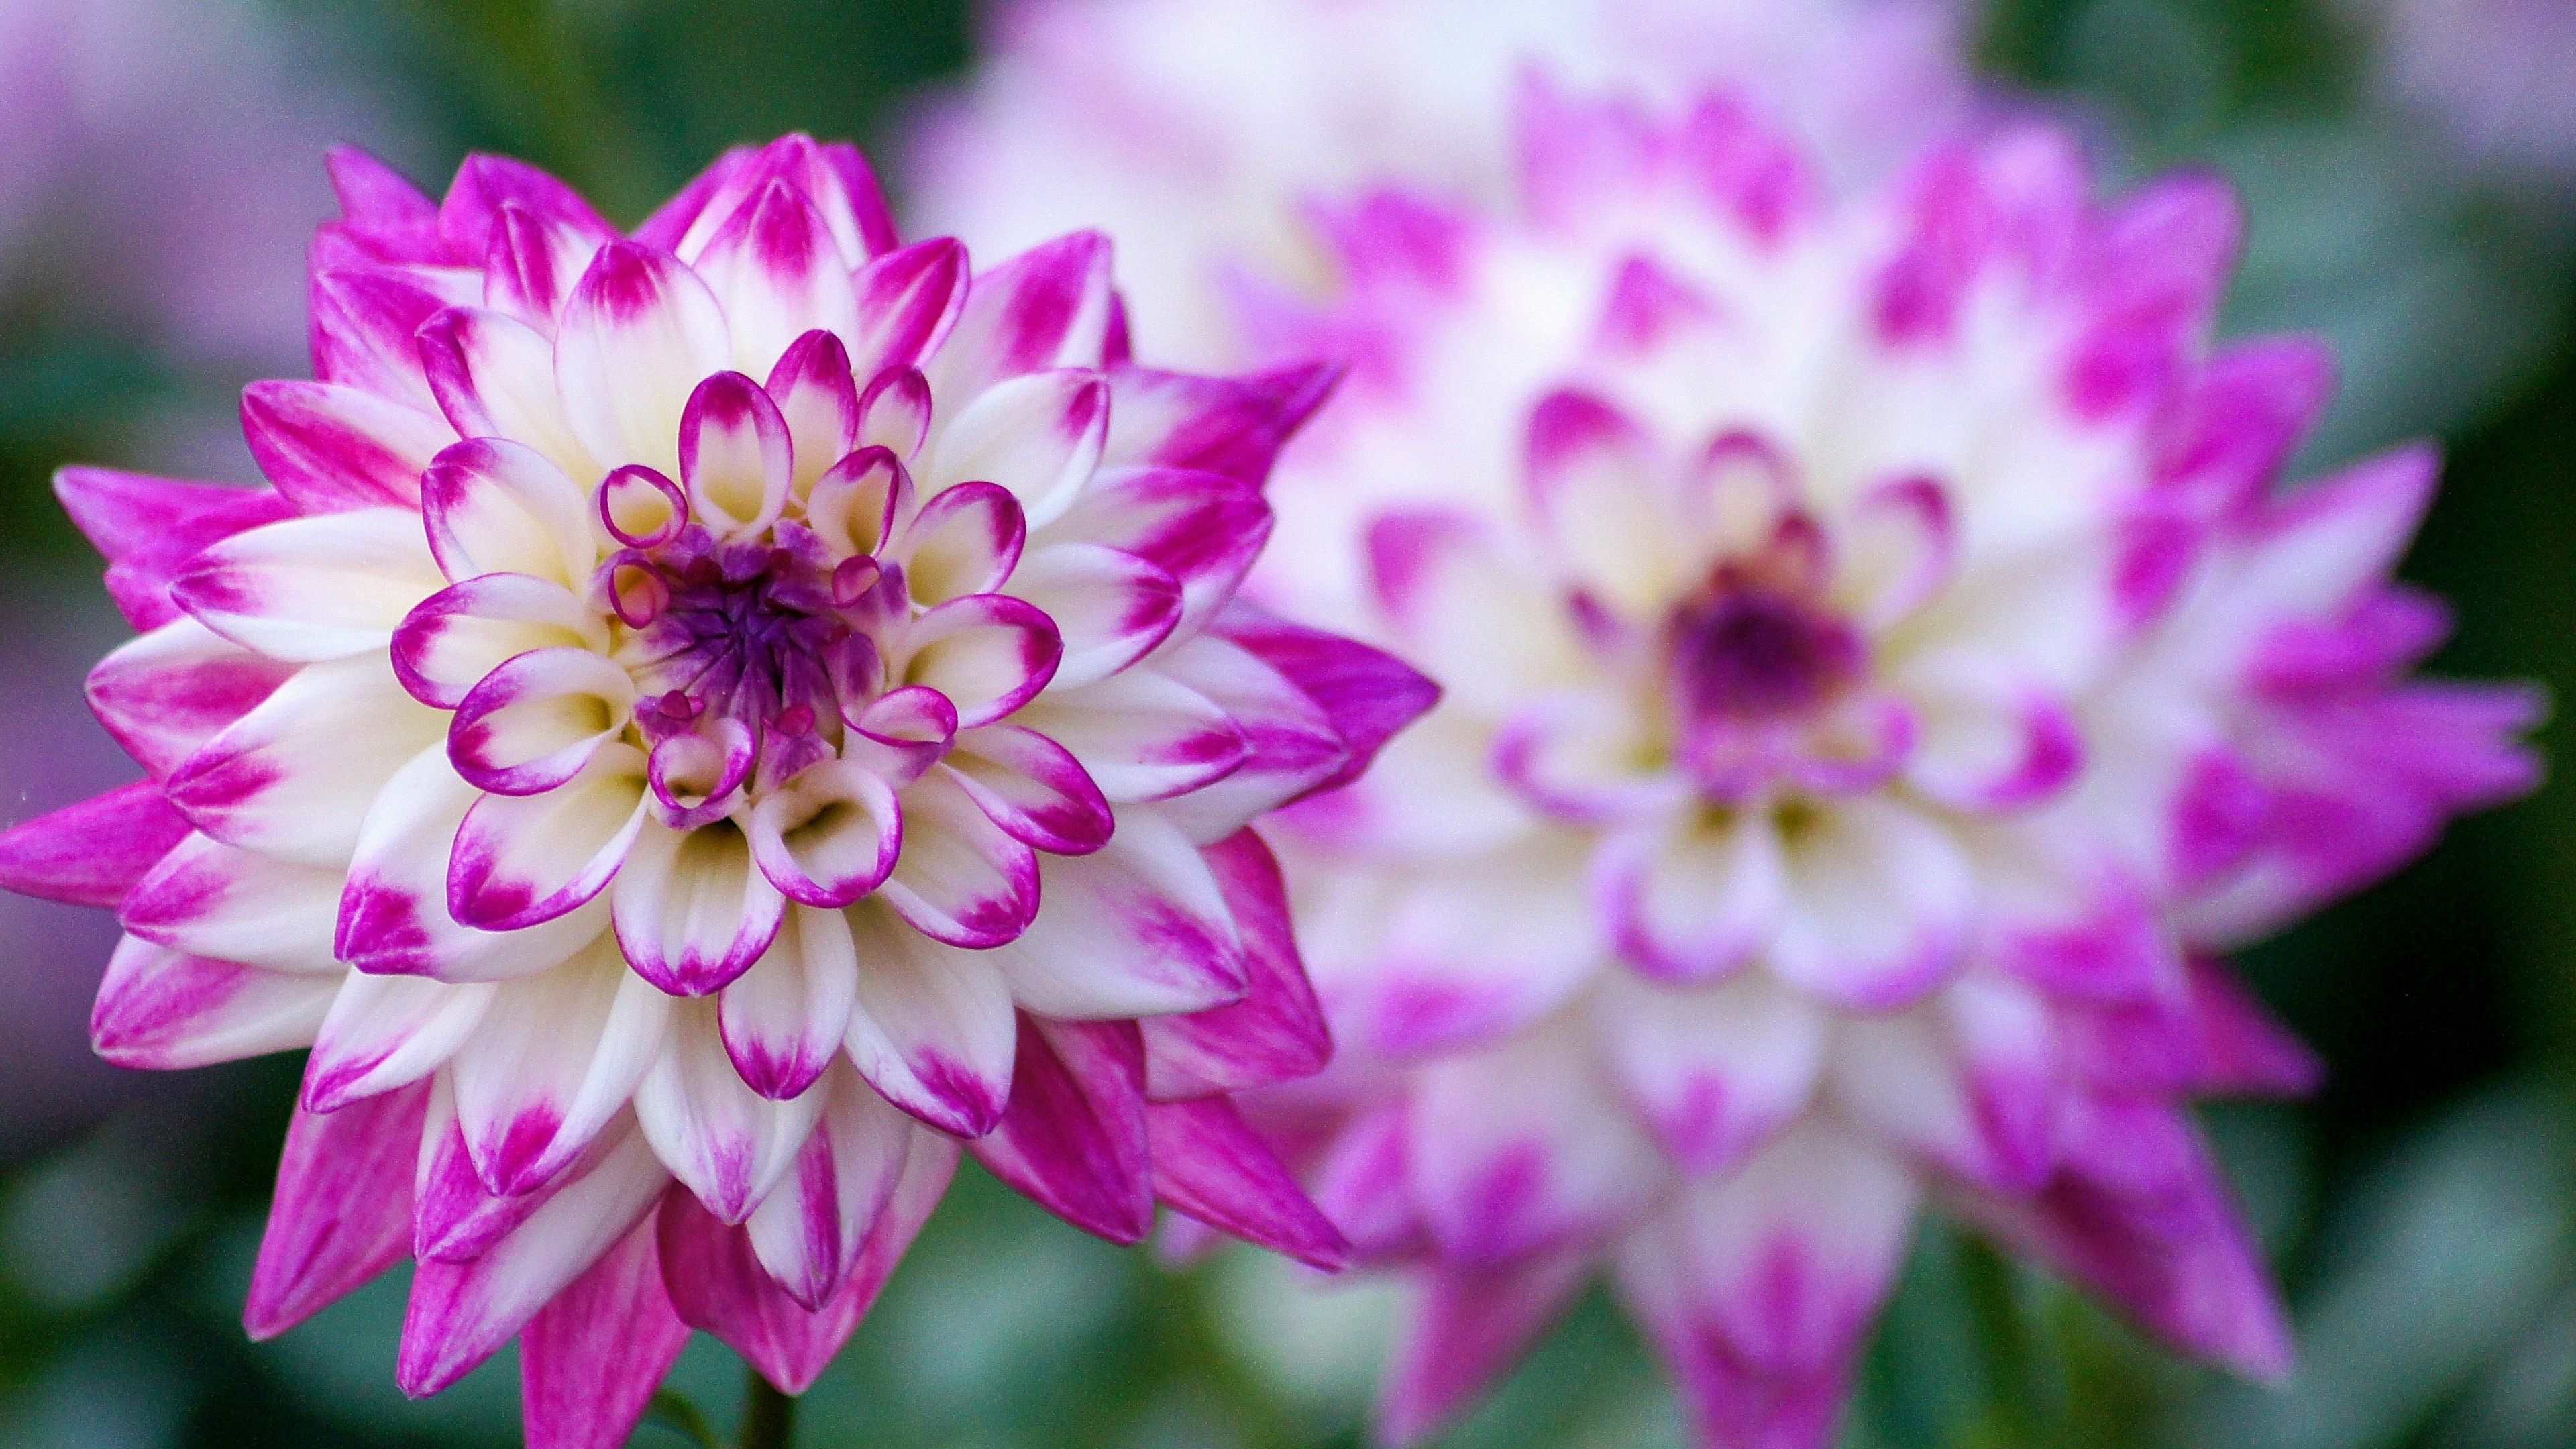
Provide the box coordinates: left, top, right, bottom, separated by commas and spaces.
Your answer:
119, 835, 340, 977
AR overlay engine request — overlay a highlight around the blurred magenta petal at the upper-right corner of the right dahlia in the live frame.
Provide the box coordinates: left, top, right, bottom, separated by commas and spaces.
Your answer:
2063, 173, 2244, 420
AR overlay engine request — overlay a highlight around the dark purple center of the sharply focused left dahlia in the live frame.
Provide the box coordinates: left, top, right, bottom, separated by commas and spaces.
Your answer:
619, 529, 873, 737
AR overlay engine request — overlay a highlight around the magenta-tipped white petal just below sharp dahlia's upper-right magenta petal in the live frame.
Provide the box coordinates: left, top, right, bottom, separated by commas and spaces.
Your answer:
1038, 467, 1273, 637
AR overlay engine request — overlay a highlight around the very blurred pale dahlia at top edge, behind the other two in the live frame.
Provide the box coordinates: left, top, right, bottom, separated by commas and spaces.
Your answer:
907, 0, 1968, 364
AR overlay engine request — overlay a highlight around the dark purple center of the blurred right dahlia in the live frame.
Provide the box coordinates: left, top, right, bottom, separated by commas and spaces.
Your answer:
1672, 583, 1862, 719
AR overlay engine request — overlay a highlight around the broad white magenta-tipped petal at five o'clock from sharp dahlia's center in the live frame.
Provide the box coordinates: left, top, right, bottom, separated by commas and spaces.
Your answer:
847, 902, 1018, 1137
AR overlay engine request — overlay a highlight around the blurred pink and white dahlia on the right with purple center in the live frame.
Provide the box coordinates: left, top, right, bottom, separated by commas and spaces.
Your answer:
1254, 88, 2535, 1449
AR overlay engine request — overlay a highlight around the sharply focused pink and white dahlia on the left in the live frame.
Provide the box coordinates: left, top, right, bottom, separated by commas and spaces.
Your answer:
0, 137, 1430, 1446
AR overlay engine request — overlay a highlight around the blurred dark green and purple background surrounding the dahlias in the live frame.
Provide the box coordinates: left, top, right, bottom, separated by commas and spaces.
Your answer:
0, 0, 2576, 1449
